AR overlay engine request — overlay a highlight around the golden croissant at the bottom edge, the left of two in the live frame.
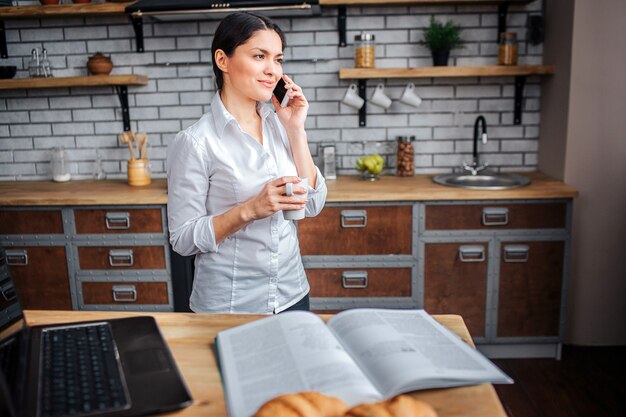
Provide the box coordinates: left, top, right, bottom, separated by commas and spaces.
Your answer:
253, 391, 348, 417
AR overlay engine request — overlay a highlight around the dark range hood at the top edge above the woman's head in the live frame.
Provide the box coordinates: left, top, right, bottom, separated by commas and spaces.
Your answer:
126, 0, 320, 20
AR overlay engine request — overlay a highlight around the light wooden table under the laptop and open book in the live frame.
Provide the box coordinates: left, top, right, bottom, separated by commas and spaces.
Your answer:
25, 310, 506, 417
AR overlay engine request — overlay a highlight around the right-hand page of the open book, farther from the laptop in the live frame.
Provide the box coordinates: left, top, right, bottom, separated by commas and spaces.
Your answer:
328, 309, 512, 397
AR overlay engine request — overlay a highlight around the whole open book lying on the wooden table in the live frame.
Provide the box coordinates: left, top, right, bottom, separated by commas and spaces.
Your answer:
216, 309, 513, 417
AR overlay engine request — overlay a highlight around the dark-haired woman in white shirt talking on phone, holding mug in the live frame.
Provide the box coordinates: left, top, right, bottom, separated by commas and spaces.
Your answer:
167, 13, 327, 314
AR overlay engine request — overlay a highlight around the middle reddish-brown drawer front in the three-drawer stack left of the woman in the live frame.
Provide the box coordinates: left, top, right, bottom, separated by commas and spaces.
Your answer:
78, 246, 165, 270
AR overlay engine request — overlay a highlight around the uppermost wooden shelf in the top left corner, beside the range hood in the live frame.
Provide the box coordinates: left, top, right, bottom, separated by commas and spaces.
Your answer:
0, 1, 134, 19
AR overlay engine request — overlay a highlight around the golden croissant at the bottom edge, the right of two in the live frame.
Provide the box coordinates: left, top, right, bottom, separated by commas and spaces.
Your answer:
344, 395, 437, 417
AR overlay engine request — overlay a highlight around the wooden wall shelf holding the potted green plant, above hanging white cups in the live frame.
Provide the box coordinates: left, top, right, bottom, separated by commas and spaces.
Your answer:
339, 65, 554, 80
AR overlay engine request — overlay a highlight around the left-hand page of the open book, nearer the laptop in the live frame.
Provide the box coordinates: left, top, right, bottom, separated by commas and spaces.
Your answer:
217, 312, 382, 417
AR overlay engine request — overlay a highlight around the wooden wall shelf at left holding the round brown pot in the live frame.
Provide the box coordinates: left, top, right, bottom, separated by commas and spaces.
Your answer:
0, 74, 148, 90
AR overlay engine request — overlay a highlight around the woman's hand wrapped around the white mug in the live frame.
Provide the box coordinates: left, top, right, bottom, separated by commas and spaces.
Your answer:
244, 177, 307, 220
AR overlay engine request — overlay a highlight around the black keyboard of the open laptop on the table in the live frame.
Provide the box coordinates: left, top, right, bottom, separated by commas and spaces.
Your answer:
40, 323, 129, 417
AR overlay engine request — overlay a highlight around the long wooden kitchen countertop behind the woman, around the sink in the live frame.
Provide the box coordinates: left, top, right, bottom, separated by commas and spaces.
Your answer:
0, 172, 578, 206
